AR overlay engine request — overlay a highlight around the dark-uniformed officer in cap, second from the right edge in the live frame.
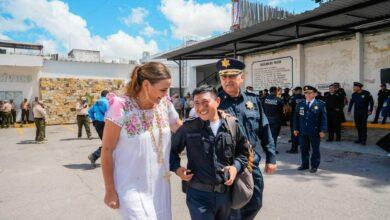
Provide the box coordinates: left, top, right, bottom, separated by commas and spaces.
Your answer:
348, 82, 374, 145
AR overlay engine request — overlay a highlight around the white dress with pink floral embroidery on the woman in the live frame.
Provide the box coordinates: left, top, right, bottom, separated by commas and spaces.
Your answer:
106, 94, 179, 220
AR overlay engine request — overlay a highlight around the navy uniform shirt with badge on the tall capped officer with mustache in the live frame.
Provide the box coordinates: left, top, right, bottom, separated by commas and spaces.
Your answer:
218, 91, 276, 164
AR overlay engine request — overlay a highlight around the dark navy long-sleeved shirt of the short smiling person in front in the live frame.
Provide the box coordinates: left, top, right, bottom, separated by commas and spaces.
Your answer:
170, 114, 250, 185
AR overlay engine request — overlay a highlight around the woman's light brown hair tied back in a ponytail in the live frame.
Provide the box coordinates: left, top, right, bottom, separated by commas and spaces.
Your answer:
126, 62, 171, 97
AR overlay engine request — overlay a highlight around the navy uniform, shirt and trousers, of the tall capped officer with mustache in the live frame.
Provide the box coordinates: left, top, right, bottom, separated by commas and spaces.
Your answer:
218, 91, 276, 219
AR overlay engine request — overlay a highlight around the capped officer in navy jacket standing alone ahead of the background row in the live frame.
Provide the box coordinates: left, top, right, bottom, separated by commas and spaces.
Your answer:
294, 86, 327, 173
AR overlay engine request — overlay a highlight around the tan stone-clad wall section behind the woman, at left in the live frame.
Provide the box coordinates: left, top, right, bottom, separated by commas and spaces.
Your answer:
39, 78, 125, 124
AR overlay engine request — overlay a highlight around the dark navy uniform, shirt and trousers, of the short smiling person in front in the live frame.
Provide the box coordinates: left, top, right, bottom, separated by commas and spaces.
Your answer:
170, 112, 250, 220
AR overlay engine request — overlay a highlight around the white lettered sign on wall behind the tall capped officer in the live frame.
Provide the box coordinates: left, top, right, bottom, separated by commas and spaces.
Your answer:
252, 57, 293, 90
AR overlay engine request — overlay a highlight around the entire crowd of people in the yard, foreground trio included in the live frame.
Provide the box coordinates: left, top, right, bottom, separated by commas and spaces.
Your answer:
0, 58, 390, 220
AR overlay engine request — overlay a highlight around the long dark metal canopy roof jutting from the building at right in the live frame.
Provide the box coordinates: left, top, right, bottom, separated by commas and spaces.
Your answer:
156, 0, 390, 60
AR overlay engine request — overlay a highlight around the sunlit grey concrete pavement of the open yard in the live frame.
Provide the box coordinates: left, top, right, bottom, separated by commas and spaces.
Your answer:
0, 125, 390, 220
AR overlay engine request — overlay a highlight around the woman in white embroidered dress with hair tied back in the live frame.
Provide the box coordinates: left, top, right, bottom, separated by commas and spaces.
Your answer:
102, 62, 181, 220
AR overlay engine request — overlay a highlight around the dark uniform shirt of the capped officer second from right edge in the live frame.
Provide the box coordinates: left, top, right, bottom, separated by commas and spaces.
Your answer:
348, 90, 374, 112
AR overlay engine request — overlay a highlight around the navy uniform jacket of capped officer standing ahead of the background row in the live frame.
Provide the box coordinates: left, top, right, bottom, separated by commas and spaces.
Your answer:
294, 99, 327, 136
